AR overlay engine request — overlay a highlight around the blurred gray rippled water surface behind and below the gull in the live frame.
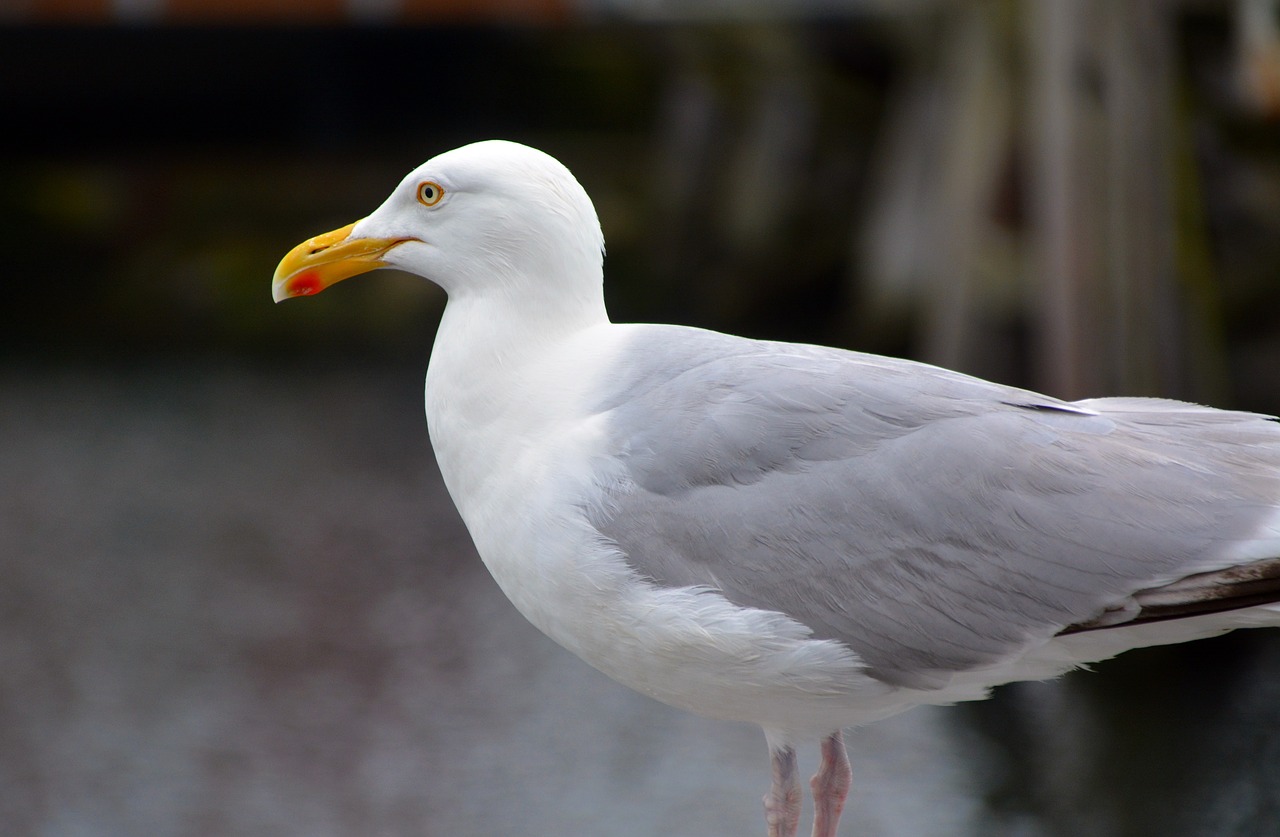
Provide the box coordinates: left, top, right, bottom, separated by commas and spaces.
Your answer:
0, 365, 1280, 837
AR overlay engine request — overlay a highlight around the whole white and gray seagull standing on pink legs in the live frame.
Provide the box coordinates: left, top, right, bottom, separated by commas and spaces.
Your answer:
271, 141, 1280, 837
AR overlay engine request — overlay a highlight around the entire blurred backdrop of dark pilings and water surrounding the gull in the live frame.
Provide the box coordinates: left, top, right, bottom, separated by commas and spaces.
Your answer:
0, 0, 1280, 837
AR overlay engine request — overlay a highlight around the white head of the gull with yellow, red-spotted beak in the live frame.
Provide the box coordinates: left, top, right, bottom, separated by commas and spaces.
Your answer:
271, 140, 604, 302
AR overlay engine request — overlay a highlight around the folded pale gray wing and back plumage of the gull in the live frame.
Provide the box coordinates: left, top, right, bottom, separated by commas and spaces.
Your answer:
593, 326, 1280, 686
